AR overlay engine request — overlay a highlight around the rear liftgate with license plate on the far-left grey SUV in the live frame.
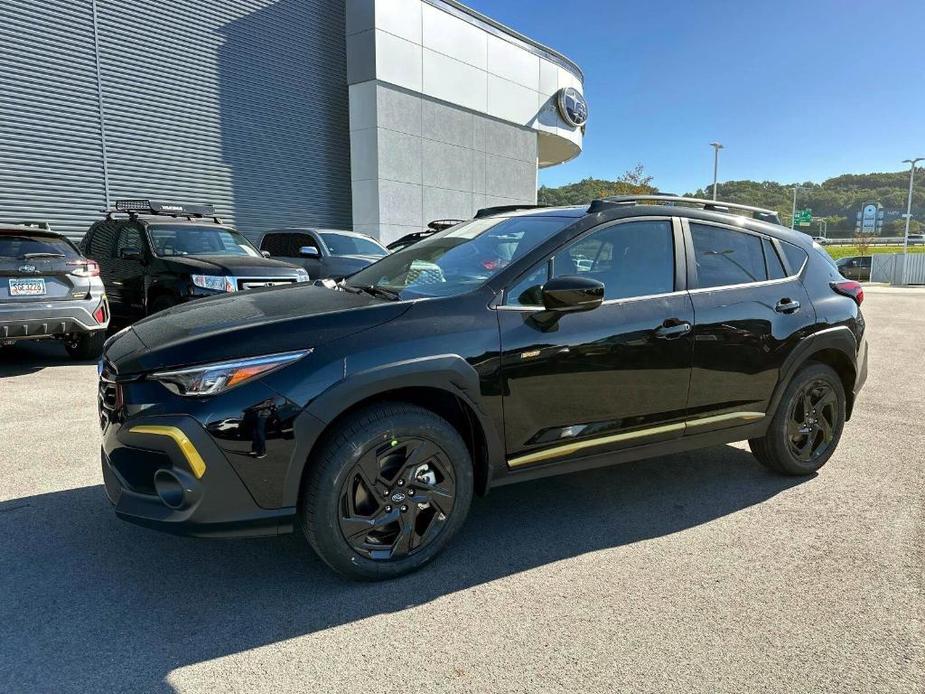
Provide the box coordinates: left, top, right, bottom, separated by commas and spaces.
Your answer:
0, 230, 90, 305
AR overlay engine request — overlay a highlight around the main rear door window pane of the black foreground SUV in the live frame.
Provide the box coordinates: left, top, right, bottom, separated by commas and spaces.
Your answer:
691, 224, 768, 288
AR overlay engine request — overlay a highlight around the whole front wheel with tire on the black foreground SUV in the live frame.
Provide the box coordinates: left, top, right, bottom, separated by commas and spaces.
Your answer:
299, 402, 473, 581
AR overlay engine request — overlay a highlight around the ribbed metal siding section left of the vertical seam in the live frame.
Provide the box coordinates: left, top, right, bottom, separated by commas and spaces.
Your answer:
0, 0, 104, 235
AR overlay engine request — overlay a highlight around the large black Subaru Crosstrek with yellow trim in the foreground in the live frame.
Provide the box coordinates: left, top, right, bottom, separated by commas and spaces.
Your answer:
99, 198, 867, 579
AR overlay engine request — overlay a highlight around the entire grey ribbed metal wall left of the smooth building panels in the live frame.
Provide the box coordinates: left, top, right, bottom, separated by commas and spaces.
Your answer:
0, 0, 352, 241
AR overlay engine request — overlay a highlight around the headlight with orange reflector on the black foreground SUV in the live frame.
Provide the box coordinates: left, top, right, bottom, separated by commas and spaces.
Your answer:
151, 349, 312, 397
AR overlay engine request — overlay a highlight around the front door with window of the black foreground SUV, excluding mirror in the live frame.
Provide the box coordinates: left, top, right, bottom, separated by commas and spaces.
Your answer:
498, 219, 694, 467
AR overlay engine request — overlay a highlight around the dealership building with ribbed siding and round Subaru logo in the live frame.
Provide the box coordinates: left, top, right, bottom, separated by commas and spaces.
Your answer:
0, 0, 587, 241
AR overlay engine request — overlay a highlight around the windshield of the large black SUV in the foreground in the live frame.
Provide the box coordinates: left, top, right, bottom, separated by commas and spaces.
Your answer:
347, 215, 575, 299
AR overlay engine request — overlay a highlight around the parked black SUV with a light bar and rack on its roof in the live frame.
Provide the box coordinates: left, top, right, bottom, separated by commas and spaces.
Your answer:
80, 200, 308, 322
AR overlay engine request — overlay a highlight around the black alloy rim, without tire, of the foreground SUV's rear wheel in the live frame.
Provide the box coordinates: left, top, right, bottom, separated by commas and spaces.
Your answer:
787, 379, 838, 463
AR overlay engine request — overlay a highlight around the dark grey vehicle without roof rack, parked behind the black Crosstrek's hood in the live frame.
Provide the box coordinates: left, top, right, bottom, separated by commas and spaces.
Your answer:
247, 228, 389, 280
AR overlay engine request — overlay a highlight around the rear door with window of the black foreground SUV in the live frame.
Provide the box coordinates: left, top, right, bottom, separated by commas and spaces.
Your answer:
684, 219, 815, 434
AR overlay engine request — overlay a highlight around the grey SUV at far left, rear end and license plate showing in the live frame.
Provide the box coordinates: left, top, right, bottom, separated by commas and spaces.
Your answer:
0, 224, 109, 359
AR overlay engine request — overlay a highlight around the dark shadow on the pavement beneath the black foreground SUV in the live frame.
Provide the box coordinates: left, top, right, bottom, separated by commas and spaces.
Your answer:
0, 446, 806, 692
